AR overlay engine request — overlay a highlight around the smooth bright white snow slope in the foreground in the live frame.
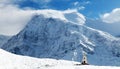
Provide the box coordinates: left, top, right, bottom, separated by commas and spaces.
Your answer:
0, 49, 120, 69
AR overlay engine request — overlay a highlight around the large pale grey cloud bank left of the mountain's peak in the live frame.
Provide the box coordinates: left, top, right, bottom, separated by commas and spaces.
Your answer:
0, 5, 30, 35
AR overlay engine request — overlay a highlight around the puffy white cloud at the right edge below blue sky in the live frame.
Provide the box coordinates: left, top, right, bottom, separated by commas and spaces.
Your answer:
100, 8, 120, 23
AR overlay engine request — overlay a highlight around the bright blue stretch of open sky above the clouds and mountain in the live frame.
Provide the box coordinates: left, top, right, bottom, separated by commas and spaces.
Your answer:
14, 0, 120, 18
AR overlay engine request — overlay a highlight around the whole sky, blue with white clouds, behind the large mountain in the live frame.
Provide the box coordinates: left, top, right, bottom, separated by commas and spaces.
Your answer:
0, 0, 120, 36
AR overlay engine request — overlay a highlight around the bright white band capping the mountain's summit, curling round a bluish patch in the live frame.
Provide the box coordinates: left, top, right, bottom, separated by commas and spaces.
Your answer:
32, 9, 86, 25
